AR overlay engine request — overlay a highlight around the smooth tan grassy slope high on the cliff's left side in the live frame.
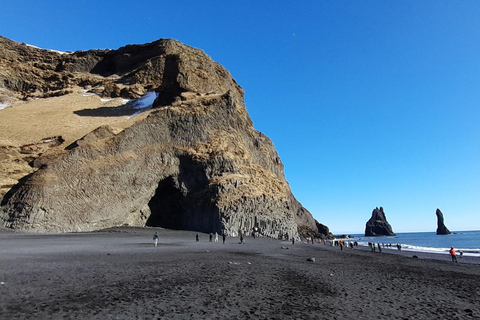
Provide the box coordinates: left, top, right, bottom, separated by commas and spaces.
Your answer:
0, 89, 149, 199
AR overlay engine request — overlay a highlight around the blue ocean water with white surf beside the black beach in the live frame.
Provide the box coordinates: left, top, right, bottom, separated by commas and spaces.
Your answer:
348, 230, 480, 257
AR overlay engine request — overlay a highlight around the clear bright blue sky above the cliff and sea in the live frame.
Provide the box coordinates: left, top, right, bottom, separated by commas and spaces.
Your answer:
0, 0, 480, 234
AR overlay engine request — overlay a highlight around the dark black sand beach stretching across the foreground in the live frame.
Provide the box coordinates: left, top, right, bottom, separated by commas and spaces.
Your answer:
0, 228, 480, 319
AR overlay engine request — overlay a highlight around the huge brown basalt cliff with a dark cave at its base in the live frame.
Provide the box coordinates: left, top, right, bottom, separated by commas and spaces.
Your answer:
0, 37, 330, 237
